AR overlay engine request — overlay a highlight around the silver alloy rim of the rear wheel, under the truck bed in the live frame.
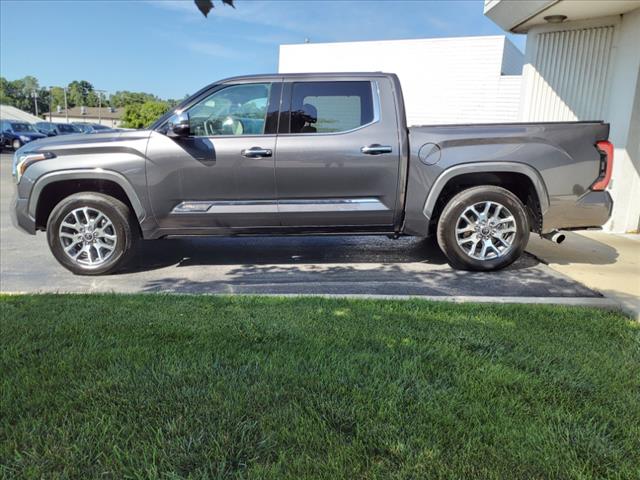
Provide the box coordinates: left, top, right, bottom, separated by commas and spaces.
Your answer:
456, 202, 517, 260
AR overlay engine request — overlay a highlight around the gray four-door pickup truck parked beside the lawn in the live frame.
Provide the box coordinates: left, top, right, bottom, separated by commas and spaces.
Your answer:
13, 73, 613, 275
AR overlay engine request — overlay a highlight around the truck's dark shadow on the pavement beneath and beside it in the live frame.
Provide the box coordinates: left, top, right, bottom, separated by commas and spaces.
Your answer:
117, 237, 599, 297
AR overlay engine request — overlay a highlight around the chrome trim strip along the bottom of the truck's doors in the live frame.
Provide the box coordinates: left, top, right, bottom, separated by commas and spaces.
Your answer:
171, 198, 389, 215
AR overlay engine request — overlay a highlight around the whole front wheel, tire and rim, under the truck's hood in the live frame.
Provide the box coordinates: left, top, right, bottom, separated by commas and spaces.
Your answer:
47, 192, 138, 275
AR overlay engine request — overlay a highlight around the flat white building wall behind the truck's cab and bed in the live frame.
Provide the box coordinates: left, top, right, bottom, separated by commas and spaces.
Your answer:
279, 36, 523, 125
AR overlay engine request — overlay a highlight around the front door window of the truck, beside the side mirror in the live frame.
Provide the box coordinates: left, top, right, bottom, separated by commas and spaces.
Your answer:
189, 83, 271, 137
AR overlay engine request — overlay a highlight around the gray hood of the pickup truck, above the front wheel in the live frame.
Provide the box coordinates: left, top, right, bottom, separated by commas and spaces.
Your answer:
18, 130, 151, 155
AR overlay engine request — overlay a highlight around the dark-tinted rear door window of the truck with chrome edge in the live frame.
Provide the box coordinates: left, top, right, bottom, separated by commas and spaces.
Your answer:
289, 81, 373, 133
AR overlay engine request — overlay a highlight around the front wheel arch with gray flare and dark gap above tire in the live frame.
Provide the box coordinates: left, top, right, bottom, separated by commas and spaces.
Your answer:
28, 169, 146, 230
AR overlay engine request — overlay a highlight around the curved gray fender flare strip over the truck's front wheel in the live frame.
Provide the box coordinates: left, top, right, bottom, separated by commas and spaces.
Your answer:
29, 168, 146, 222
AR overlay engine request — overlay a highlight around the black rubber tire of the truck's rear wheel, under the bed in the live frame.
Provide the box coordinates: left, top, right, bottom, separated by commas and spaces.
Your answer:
437, 185, 529, 271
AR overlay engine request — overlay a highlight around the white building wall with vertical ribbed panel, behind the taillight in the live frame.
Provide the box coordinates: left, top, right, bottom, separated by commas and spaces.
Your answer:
520, 9, 640, 232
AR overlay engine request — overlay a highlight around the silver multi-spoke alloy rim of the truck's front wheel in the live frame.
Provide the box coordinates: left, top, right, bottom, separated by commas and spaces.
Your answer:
58, 207, 118, 268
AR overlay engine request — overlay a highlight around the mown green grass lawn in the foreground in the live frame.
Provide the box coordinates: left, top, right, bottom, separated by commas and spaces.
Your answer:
0, 295, 640, 479
